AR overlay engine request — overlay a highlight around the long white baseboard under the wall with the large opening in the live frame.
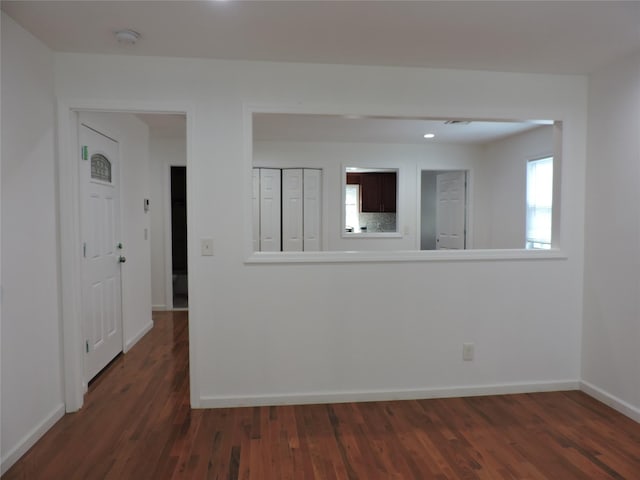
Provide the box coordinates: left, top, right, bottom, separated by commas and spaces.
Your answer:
198, 380, 580, 408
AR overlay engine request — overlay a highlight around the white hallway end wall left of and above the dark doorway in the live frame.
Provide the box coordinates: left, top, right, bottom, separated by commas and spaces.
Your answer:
149, 132, 187, 310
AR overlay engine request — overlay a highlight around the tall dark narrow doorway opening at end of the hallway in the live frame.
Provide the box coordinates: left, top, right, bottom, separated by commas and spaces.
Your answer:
171, 166, 189, 310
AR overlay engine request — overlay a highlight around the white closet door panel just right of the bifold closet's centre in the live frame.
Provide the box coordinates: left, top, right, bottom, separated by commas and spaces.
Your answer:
282, 168, 303, 252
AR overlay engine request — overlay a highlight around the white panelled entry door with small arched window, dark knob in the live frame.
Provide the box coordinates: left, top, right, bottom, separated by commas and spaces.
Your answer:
79, 124, 124, 382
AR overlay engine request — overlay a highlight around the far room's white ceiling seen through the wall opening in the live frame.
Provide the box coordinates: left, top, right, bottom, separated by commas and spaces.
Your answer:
253, 113, 552, 145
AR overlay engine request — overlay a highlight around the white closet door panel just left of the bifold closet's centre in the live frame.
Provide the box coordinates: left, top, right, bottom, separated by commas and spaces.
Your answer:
260, 168, 281, 252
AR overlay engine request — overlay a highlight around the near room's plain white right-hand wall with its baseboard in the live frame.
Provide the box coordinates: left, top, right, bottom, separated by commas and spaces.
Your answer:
582, 49, 640, 421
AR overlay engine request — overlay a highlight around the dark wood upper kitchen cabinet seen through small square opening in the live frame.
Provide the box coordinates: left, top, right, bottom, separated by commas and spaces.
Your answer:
347, 172, 397, 213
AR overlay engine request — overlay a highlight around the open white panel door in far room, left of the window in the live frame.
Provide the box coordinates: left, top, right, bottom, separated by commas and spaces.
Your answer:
436, 171, 467, 250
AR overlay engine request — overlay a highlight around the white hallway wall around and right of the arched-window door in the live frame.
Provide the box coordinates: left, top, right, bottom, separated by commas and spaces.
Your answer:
82, 112, 153, 352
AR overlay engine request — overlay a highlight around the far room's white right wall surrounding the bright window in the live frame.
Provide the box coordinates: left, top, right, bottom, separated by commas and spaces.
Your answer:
474, 126, 553, 248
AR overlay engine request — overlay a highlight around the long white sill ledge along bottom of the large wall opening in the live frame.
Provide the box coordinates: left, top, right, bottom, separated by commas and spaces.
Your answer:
245, 248, 567, 264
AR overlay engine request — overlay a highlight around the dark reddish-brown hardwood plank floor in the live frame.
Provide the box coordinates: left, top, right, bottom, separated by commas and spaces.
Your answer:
3, 312, 640, 480
